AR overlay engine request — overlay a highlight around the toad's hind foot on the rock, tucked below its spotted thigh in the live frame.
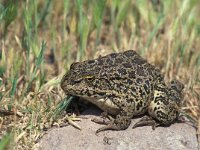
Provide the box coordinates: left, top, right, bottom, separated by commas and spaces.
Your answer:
133, 116, 160, 130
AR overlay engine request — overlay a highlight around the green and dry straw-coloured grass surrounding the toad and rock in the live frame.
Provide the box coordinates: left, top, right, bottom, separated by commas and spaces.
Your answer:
0, 0, 200, 149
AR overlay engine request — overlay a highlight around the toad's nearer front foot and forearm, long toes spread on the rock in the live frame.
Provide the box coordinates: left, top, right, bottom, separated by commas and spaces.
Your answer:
92, 115, 131, 133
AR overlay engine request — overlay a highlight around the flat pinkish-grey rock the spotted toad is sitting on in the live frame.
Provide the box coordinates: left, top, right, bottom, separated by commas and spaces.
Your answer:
39, 108, 198, 150
